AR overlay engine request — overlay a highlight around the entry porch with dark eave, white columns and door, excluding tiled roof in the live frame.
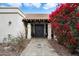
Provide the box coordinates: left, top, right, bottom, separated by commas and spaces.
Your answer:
23, 19, 52, 39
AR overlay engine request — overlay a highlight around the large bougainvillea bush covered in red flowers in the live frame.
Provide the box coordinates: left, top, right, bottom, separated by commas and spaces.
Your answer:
49, 3, 79, 48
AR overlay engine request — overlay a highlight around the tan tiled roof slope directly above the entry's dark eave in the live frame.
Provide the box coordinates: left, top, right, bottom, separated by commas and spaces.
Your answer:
25, 14, 48, 19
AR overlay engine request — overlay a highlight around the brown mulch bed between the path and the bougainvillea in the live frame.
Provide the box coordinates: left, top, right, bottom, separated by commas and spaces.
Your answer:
48, 39, 71, 56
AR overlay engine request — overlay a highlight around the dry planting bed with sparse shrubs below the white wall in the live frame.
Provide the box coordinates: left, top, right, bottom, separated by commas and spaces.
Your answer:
0, 35, 30, 56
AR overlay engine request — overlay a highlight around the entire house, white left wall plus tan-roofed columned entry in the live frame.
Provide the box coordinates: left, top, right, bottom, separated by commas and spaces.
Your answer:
0, 7, 52, 42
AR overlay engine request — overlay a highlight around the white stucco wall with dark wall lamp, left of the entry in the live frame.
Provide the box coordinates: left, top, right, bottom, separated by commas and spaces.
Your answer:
0, 7, 25, 42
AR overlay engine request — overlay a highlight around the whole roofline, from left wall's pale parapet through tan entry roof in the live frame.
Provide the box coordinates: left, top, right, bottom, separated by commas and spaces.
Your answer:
0, 7, 48, 20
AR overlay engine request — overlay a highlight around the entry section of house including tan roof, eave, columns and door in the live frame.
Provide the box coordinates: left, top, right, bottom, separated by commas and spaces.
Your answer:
23, 14, 52, 39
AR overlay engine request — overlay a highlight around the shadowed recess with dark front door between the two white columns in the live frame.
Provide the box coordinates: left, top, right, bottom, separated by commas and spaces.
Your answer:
31, 23, 48, 38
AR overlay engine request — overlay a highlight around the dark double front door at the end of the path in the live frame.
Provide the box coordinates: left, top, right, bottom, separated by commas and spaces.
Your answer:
35, 24, 44, 37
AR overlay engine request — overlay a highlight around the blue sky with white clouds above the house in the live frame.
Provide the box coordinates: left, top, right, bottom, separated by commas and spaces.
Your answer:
0, 3, 58, 14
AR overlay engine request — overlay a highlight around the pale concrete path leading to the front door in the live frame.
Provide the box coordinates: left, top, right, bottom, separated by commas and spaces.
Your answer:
21, 39, 58, 56
